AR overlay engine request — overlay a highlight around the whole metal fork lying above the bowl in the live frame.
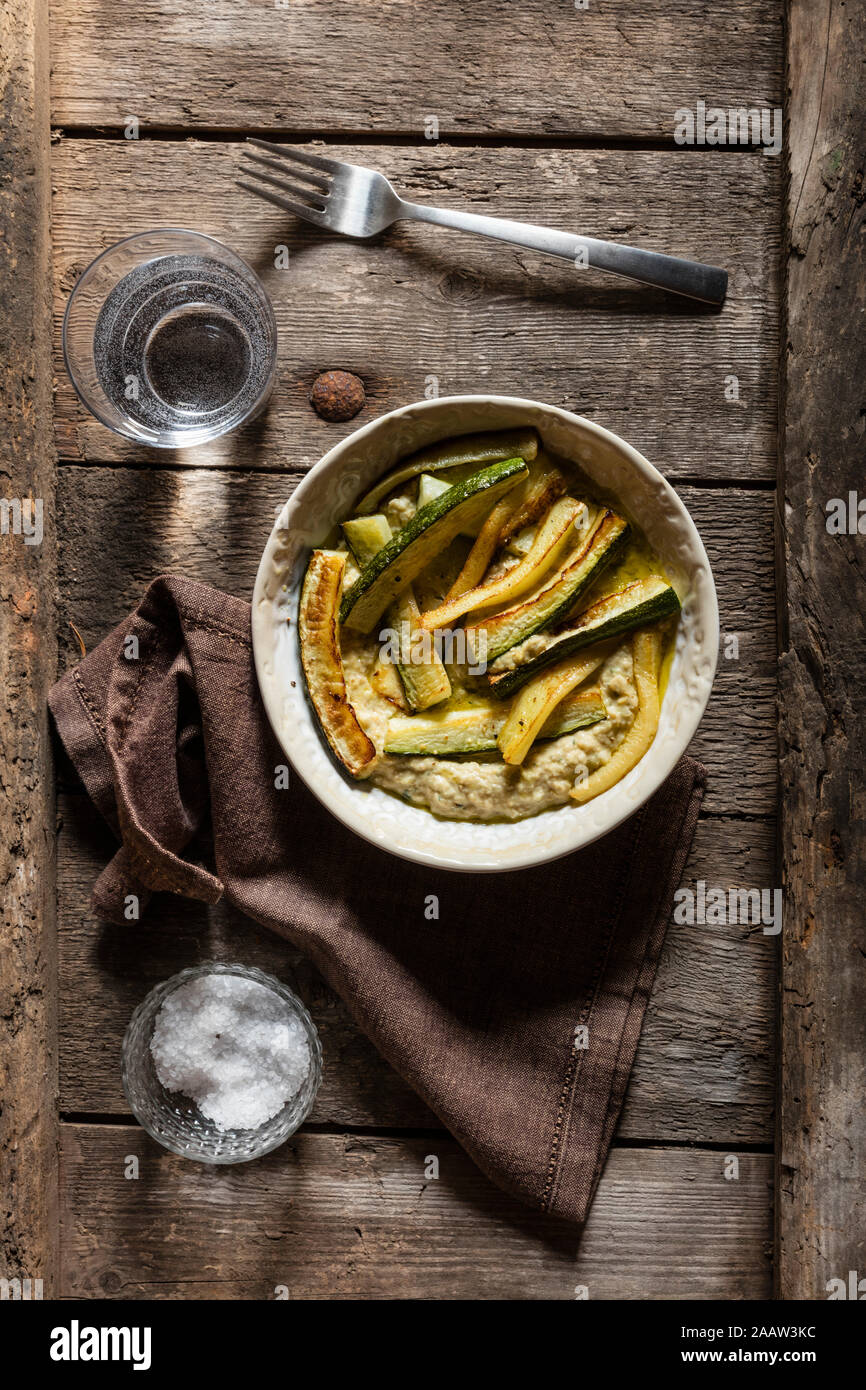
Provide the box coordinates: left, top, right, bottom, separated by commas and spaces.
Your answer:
236, 139, 727, 304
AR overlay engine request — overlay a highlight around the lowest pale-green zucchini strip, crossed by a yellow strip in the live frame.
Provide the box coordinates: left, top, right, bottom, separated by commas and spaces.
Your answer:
385, 685, 607, 758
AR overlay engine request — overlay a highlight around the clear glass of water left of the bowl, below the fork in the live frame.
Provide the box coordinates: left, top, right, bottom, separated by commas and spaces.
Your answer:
63, 227, 277, 449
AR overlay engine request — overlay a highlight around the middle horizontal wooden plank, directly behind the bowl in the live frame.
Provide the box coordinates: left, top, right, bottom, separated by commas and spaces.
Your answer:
58, 467, 777, 815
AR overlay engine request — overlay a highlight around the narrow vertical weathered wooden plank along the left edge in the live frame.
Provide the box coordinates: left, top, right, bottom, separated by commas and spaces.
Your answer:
0, 0, 57, 1297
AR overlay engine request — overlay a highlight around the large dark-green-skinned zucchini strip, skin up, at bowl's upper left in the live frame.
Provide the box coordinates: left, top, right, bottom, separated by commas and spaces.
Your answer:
339, 457, 528, 632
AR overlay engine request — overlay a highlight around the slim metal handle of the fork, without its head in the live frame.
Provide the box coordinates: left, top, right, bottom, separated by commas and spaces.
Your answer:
398, 199, 727, 304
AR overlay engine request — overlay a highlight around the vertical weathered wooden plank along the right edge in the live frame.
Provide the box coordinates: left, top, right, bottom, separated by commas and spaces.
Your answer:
778, 0, 866, 1298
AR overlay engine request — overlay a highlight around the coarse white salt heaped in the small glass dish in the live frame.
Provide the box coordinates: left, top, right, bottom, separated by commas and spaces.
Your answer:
150, 974, 311, 1130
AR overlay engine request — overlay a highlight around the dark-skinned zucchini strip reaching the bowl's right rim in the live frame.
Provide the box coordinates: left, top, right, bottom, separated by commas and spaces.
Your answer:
487, 574, 680, 695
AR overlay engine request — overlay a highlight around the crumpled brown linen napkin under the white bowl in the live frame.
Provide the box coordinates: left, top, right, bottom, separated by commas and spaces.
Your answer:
50, 578, 705, 1222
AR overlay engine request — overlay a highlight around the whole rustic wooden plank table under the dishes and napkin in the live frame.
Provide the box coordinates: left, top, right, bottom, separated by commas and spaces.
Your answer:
0, 0, 866, 1300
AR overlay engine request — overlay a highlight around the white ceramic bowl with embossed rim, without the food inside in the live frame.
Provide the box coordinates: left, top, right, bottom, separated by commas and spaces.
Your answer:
253, 396, 719, 872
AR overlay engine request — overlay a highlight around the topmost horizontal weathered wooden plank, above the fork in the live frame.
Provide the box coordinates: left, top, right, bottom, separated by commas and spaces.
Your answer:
51, 0, 781, 140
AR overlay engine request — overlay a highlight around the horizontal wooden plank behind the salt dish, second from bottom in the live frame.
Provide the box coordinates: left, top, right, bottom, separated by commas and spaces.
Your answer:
58, 795, 777, 1144
